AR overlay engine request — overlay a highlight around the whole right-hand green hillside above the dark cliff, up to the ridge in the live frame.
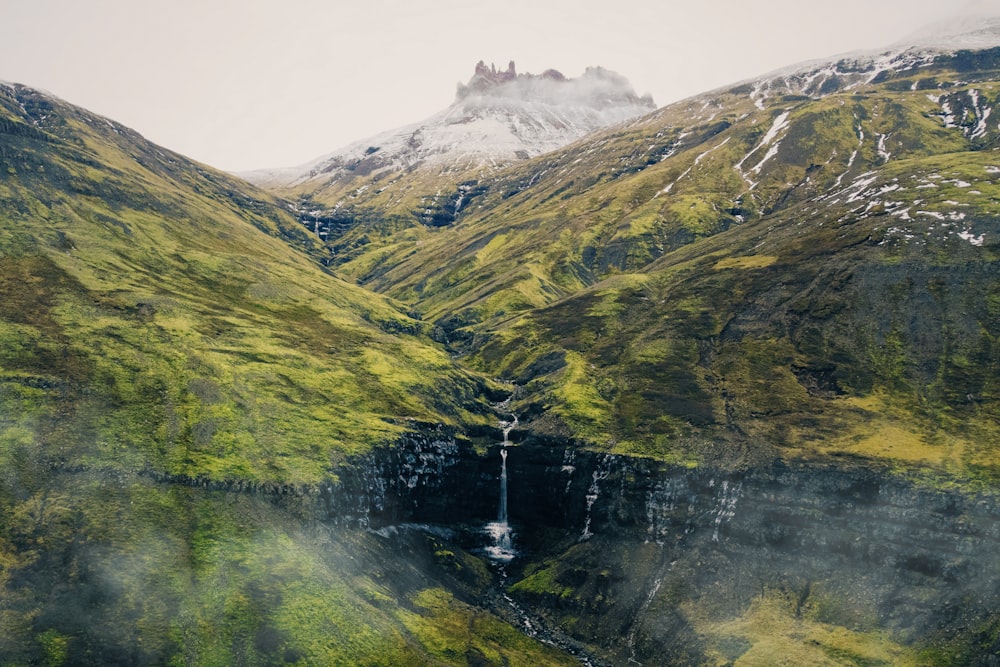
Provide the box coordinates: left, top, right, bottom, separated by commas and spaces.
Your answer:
302, 51, 1000, 476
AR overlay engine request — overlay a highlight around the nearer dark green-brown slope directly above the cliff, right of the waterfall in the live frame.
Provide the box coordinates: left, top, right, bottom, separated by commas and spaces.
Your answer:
475, 145, 1000, 475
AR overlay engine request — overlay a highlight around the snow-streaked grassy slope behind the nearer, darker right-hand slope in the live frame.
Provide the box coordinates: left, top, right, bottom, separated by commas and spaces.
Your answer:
337, 75, 967, 321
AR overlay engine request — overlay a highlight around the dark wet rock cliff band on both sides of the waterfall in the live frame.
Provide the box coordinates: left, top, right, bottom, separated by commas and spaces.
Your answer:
323, 436, 1000, 664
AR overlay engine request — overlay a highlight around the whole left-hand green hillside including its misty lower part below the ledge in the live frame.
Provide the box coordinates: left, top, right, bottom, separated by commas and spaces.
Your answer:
0, 88, 584, 665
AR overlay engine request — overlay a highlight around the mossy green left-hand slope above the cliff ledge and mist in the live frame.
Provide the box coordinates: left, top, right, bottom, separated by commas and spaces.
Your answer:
0, 86, 492, 484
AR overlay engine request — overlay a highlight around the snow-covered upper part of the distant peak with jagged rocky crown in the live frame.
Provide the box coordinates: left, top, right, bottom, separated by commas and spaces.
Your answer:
242, 61, 655, 187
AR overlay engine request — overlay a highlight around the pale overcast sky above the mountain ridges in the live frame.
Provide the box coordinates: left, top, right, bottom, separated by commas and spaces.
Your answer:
0, 0, 998, 170
